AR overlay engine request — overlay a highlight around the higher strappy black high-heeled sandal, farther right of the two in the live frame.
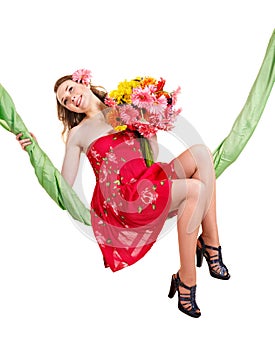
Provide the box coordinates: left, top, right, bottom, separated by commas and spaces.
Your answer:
196, 236, 230, 280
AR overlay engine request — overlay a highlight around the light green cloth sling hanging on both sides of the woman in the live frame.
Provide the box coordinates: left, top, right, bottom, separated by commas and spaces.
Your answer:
0, 30, 275, 225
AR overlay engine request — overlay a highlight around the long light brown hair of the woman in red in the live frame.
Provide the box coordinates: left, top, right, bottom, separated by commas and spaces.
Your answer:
54, 75, 107, 139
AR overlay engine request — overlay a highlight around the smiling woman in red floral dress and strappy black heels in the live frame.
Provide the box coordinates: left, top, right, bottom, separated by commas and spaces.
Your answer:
16, 70, 230, 318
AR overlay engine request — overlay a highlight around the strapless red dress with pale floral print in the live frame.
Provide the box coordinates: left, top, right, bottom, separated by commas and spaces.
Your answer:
87, 130, 176, 271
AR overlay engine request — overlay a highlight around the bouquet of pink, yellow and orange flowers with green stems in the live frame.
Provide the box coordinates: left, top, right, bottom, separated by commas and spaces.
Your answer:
105, 77, 181, 165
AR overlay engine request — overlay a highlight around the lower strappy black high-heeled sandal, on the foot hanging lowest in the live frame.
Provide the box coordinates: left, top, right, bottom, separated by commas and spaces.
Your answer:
168, 273, 201, 318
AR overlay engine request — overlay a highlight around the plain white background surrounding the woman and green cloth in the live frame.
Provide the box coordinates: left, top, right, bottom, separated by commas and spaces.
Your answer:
0, 0, 275, 350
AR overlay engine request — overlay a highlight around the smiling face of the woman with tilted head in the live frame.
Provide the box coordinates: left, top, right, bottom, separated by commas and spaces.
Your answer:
56, 80, 92, 113
